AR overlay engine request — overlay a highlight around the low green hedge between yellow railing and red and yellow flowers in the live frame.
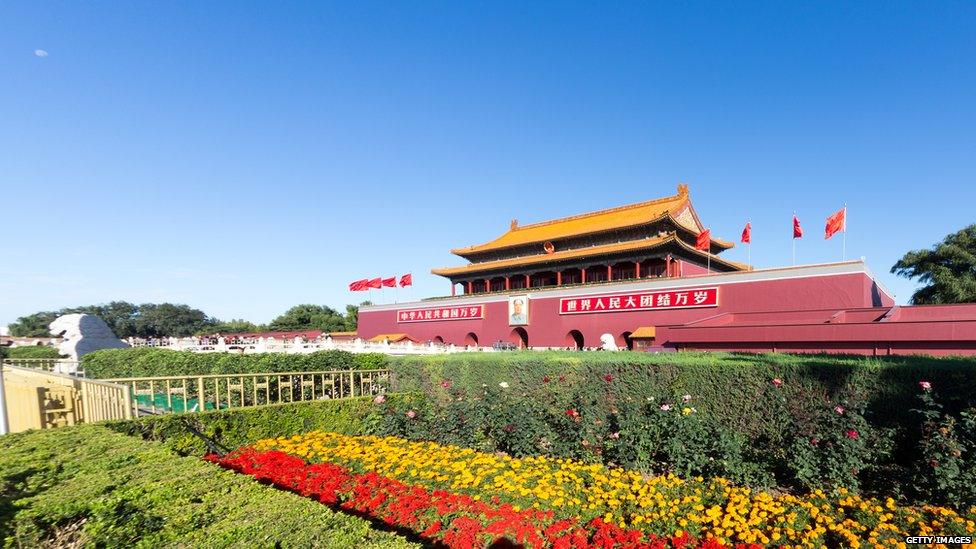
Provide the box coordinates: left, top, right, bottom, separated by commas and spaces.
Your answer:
105, 395, 411, 456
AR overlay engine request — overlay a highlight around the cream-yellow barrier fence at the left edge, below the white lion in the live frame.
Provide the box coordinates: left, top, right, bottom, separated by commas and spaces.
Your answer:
0, 364, 135, 434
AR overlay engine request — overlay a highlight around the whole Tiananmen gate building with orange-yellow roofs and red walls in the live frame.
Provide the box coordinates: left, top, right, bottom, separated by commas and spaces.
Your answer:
358, 185, 976, 355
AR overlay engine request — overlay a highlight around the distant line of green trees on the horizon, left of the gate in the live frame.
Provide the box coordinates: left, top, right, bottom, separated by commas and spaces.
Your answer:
9, 301, 368, 339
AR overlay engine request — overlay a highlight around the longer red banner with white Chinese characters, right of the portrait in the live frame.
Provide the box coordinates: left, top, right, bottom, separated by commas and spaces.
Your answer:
559, 288, 718, 315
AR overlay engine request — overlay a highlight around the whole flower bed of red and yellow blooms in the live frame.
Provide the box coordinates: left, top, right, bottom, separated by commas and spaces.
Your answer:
224, 432, 976, 547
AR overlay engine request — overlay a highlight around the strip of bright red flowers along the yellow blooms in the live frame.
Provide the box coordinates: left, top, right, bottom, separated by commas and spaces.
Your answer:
207, 448, 732, 549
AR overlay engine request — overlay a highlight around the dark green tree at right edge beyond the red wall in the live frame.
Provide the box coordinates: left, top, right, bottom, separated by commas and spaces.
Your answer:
891, 225, 976, 305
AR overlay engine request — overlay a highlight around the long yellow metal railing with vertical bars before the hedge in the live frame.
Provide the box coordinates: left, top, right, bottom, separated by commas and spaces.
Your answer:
104, 370, 391, 414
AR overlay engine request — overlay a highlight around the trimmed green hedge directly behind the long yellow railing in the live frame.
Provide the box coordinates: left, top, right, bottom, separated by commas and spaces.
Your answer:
82, 348, 386, 379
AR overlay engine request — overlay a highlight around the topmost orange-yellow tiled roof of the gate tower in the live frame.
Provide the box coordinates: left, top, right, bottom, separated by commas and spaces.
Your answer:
451, 185, 699, 255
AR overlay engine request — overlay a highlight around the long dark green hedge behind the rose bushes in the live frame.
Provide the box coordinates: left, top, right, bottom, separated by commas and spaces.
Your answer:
390, 352, 976, 435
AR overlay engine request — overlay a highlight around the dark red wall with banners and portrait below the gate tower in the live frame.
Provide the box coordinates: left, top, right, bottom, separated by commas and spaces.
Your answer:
358, 261, 976, 355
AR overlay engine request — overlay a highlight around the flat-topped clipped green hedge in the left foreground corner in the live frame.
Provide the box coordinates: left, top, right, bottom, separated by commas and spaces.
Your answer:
0, 425, 413, 548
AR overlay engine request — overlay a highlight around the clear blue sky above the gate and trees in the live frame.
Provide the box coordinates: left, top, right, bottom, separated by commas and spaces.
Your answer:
0, 1, 976, 325
